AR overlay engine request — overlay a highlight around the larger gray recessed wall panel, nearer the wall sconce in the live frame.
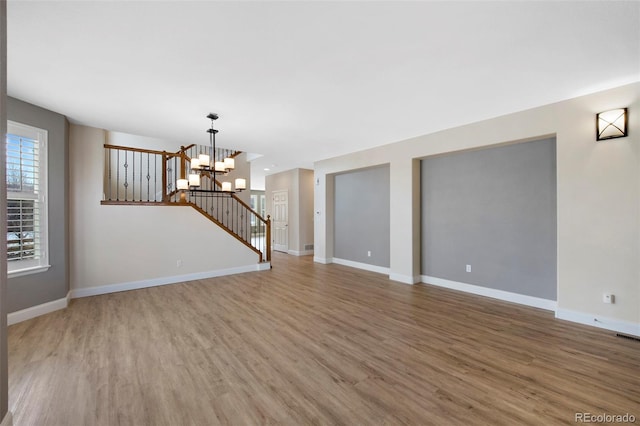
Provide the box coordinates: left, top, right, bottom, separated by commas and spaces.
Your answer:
421, 138, 557, 300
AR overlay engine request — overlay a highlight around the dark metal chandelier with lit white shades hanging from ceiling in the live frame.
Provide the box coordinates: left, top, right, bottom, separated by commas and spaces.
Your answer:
176, 113, 247, 196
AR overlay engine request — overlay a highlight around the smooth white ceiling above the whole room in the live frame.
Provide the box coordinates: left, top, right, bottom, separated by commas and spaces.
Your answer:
7, 0, 640, 187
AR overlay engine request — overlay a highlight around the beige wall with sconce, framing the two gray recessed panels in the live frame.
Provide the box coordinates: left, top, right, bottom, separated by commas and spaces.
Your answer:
315, 83, 640, 334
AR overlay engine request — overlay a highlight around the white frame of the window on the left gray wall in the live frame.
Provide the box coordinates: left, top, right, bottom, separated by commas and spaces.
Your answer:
4, 120, 51, 278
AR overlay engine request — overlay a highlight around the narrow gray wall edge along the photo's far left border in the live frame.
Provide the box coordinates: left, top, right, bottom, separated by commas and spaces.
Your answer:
0, 1, 9, 422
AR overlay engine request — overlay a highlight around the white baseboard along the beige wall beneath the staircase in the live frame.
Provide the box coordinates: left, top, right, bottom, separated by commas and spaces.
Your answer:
71, 262, 271, 299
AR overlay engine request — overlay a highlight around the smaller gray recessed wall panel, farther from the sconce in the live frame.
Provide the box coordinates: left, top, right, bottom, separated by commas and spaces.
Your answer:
333, 165, 390, 268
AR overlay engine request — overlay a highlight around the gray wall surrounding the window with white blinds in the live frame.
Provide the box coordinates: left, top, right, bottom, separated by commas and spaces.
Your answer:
7, 97, 70, 312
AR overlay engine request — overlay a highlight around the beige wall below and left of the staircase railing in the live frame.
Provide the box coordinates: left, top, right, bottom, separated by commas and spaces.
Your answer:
69, 125, 258, 294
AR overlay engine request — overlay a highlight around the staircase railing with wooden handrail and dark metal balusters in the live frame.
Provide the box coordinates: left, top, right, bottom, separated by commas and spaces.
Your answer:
101, 144, 271, 262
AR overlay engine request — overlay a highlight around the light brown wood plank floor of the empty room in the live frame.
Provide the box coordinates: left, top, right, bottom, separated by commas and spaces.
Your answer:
9, 255, 640, 426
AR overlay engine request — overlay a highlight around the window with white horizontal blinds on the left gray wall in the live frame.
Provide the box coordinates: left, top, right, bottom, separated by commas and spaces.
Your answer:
6, 121, 49, 277
